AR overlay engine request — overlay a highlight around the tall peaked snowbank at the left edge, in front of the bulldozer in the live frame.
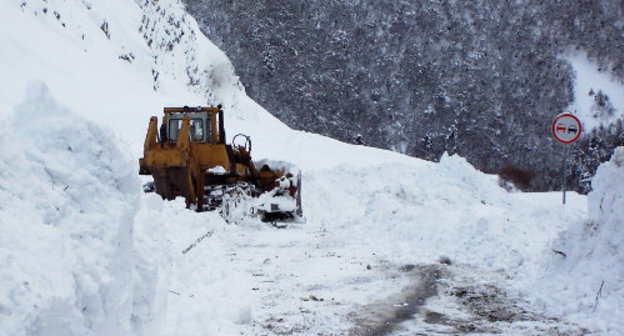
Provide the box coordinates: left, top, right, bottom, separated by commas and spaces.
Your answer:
0, 84, 149, 335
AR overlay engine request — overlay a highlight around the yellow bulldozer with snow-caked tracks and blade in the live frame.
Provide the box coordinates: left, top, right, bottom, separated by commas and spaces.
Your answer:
139, 105, 303, 222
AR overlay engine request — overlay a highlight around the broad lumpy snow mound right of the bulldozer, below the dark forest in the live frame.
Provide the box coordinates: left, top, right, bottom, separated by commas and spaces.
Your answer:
303, 153, 583, 273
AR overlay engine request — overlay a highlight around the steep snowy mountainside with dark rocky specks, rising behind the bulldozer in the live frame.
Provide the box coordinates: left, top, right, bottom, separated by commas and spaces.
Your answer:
0, 0, 281, 151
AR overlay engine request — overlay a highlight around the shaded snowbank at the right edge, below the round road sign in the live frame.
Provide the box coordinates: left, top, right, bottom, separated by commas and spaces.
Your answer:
538, 147, 624, 334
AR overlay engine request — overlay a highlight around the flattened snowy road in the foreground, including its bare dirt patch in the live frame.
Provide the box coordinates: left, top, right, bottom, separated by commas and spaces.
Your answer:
155, 207, 590, 336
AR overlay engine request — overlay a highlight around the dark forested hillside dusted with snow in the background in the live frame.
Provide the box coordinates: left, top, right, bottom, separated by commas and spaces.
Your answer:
185, 0, 624, 191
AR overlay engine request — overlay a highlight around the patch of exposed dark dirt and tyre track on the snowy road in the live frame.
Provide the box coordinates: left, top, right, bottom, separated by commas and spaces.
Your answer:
348, 265, 592, 336
